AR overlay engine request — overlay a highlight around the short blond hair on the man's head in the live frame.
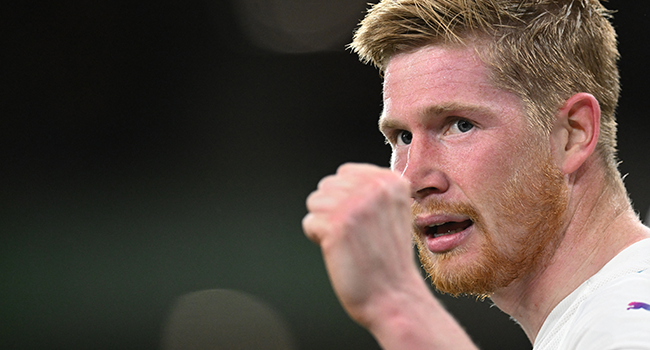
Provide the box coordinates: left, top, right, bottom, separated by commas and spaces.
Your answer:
350, 0, 620, 175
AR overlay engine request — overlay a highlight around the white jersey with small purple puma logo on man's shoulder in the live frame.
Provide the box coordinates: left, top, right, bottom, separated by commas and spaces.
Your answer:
533, 239, 650, 350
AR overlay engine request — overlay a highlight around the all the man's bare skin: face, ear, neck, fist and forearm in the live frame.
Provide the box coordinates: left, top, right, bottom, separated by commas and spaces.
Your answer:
303, 39, 650, 350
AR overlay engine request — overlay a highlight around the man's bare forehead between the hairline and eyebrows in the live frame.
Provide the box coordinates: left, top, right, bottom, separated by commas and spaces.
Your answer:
384, 45, 523, 123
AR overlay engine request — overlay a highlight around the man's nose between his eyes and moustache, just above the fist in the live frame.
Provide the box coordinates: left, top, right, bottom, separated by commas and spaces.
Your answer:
402, 140, 449, 200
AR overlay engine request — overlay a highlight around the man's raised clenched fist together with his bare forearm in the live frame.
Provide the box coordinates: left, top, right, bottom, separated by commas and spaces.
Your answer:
302, 164, 476, 350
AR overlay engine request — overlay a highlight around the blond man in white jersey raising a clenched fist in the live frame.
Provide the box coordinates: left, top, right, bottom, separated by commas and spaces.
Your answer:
303, 0, 650, 350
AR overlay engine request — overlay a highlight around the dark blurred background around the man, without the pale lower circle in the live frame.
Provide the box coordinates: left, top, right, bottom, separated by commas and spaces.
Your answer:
0, 0, 650, 350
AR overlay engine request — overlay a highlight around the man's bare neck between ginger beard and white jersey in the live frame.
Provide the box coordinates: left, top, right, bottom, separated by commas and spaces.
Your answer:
492, 165, 650, 343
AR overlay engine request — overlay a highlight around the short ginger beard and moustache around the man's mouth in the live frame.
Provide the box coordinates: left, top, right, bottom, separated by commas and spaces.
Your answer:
412, 144, 568, 297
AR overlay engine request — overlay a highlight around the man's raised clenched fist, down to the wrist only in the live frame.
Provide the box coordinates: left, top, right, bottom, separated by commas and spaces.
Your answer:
303, 164, 424, 327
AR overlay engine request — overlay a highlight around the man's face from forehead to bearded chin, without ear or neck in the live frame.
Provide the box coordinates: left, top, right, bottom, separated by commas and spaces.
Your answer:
380, 46, 567, 295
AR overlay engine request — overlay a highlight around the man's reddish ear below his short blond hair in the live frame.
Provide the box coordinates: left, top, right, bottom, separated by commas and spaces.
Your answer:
551, 93, 600, 174
